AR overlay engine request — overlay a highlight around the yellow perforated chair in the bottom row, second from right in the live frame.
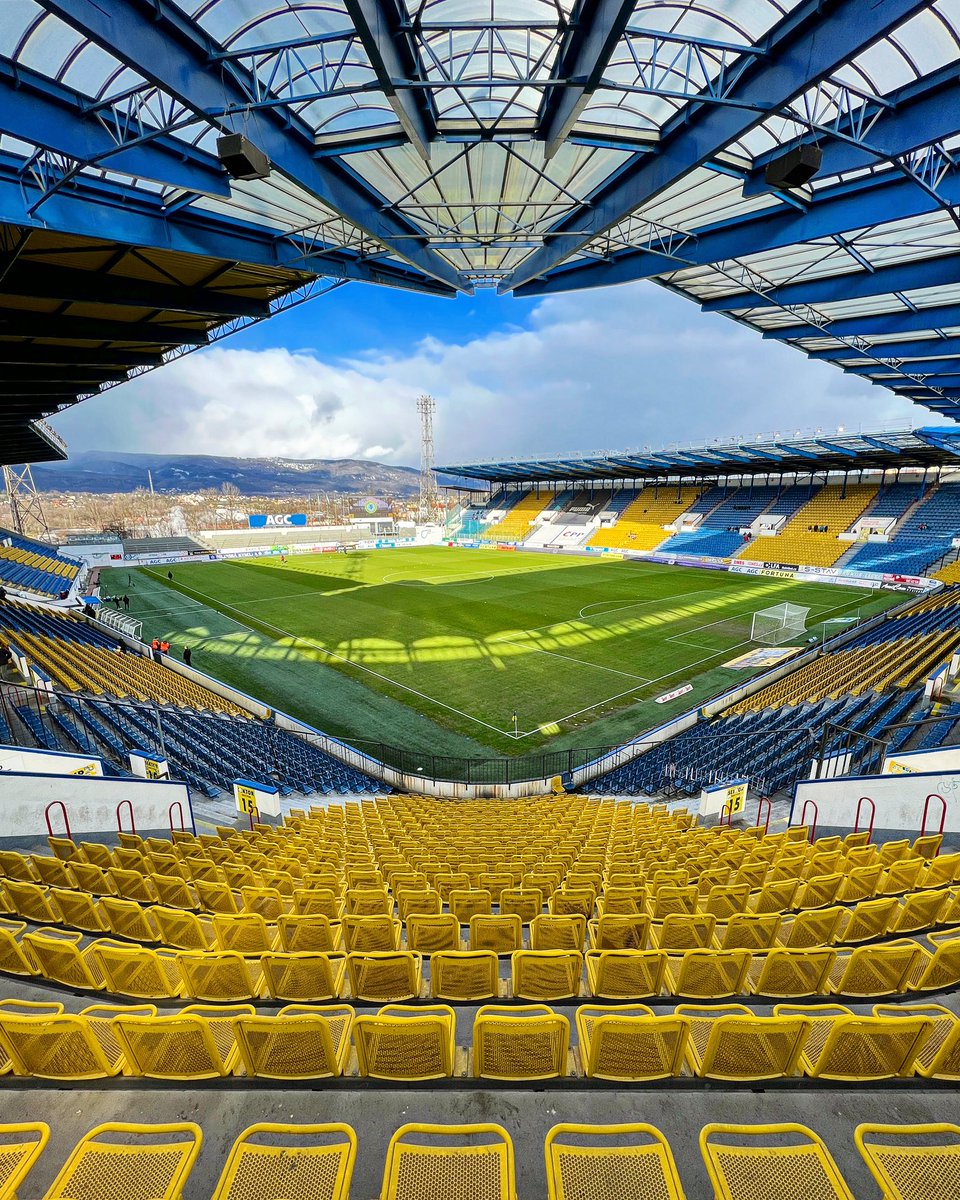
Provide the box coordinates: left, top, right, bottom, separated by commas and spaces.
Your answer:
700, 1123, 854, 1200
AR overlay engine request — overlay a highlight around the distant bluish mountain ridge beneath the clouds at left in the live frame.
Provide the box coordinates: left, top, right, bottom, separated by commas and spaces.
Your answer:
34, 450, 434, 496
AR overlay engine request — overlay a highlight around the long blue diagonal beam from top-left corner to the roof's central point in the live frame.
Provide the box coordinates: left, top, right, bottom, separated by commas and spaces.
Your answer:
40, 0, 465, 289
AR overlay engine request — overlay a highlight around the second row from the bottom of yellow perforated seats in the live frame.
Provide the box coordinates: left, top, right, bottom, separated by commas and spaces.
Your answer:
0, 1001, 960, 1082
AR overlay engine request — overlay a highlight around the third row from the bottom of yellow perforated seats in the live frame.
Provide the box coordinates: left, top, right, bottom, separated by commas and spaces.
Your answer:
7, 926, 960, 1003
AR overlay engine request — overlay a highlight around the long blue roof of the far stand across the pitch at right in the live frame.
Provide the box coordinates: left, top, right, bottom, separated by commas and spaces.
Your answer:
437, 426, 960, 477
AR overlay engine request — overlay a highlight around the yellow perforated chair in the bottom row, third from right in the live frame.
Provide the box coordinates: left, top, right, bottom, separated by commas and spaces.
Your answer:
544, 1123, 684, 1200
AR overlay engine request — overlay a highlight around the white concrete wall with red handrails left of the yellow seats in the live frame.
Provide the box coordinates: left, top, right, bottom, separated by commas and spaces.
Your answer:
0, 772, 196, 850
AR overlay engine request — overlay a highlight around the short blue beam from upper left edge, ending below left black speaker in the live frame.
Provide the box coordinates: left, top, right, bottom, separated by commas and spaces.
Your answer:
0, 58, 230, 197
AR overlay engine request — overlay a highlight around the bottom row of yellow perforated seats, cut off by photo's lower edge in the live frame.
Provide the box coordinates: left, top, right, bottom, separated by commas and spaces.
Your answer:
0, 1122, 960, 1200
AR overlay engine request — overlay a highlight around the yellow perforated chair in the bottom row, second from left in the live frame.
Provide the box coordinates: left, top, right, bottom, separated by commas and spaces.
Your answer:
43, 1121, 203, 1200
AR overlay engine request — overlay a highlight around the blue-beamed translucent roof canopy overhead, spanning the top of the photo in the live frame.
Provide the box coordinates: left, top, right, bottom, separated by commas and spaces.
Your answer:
0, 0, 960, 458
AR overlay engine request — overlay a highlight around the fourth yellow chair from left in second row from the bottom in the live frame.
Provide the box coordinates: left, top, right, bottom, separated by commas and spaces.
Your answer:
353, 1004, 456, 1080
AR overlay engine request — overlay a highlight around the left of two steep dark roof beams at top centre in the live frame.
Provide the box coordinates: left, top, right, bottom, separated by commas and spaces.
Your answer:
344, 0, 437, 162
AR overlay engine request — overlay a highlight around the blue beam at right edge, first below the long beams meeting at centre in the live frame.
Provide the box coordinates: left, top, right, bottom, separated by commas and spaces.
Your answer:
701, 254, 960, 312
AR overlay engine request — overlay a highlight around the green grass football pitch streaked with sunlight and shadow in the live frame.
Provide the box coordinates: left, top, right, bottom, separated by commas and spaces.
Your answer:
102, 547, 901, 755
